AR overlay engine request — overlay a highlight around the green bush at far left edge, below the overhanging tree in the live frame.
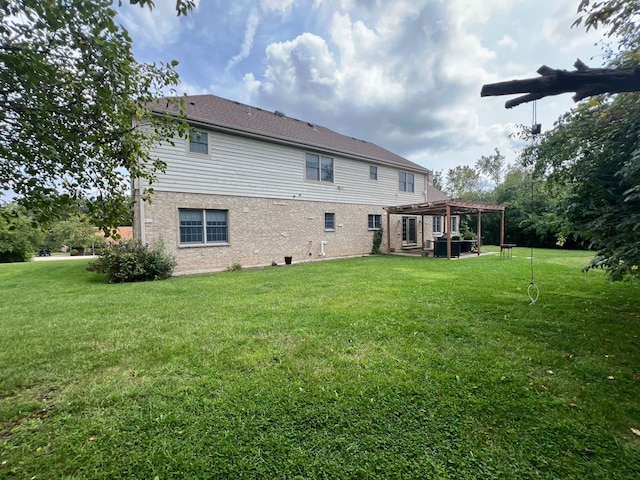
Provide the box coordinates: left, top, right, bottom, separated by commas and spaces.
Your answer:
0, 205, 43, 263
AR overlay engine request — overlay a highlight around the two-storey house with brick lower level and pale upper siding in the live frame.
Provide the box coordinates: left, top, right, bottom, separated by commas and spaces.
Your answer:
133, 95, 457, 274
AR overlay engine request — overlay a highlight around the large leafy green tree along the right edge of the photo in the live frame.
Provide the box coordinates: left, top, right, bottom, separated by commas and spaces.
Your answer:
523, 0, 640, 280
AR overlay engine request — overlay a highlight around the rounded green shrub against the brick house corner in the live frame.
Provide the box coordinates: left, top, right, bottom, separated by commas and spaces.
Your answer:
88, 240, 176, 283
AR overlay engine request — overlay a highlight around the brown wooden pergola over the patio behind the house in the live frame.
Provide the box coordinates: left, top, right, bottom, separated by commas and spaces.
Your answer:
384, 200, 507, 259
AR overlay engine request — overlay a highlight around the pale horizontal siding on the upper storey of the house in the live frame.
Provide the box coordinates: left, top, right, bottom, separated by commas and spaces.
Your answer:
152, 128, 426, 206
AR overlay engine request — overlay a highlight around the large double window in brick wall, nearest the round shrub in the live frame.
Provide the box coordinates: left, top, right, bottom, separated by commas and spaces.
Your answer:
180, 209, 229, 245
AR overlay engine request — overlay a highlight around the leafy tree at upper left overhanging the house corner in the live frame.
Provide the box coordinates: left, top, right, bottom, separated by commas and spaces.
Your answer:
0, 0, 193, 230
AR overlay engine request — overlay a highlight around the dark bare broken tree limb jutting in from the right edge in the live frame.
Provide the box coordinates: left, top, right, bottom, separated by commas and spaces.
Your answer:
480, 59, 640, 108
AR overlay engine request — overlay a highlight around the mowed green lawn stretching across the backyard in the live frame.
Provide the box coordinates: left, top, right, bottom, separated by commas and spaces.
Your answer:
0, 248, 640, 479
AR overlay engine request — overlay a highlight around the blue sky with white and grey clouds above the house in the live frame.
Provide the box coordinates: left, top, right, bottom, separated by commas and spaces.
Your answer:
119, 0, 604, 174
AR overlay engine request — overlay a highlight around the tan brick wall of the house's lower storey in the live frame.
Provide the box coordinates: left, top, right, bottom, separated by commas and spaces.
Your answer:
134, 191, 424, 275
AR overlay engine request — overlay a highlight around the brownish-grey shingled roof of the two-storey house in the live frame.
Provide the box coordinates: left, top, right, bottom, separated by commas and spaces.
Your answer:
153, 95, 430, 173
